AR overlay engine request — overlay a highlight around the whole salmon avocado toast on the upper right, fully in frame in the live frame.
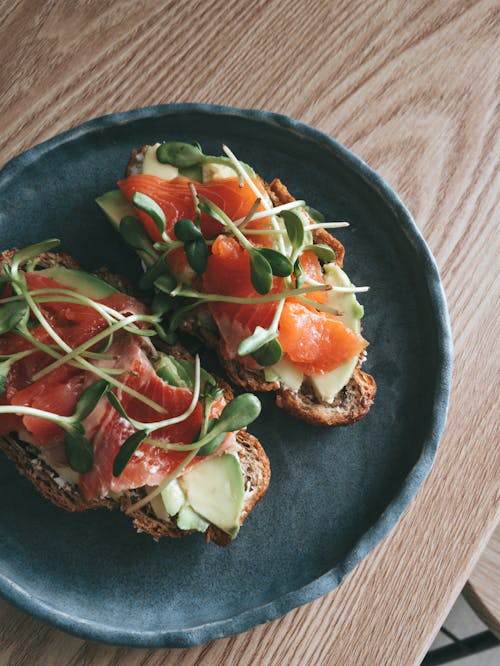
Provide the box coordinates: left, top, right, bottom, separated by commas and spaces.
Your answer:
97, 142, 376, 425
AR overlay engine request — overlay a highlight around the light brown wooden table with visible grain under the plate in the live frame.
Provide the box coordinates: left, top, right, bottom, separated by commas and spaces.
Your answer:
0, 0, 500, 666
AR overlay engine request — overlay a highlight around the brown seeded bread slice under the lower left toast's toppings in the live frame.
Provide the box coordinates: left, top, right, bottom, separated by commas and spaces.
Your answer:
0, 249, 270, 546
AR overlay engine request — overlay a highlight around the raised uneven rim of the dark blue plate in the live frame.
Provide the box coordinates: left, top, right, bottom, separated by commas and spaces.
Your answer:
0, 102, 453, 648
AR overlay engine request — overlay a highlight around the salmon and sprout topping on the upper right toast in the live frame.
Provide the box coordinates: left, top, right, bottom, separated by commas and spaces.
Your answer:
104, 142, 367, 386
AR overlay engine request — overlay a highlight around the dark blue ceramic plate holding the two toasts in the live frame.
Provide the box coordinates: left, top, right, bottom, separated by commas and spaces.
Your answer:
0, 104, 452, 647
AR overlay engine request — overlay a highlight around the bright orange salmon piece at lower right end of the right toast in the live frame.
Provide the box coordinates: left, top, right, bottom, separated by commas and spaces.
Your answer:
279, 301, 368, 375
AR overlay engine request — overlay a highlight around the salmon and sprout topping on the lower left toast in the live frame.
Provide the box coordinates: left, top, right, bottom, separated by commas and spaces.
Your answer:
0, 241, 260, 529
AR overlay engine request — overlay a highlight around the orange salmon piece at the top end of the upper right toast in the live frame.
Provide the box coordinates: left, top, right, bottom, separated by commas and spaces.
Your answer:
118, 174, 272, 247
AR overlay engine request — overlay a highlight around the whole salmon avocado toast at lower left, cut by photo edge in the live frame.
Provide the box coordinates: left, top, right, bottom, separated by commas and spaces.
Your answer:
0, 241, 270, 545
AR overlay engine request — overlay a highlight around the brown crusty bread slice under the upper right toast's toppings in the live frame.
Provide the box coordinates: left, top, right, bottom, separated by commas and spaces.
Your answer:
118, 145, 376, 426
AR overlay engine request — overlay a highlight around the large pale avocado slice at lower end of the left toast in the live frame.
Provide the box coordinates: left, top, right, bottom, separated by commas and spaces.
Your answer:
178, 453, 245, 539
